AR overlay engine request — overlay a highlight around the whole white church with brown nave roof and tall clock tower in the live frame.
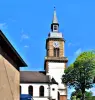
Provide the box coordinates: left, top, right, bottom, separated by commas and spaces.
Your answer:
20, 9, 68, 100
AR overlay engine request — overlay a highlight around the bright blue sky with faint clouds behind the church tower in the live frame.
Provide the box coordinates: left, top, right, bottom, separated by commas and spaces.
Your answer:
0, 0, 95, 98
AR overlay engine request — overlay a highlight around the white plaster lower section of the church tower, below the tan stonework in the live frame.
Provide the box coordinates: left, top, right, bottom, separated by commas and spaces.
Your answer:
48, 62, 66, 95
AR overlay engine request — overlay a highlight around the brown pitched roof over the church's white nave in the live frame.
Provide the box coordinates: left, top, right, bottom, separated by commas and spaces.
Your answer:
20, 71, 49, 83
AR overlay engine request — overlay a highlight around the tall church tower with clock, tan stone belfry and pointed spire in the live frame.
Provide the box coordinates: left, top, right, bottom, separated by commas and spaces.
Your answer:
44, 8, 68, 100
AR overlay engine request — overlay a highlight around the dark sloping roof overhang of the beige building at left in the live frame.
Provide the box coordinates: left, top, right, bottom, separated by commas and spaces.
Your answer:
0, 30, 27, 67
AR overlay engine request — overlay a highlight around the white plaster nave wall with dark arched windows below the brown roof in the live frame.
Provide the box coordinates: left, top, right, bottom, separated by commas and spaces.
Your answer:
20, 83, 58, 100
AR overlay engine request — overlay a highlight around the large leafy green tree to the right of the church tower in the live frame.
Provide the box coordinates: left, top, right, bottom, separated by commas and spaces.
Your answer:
62, 51, 95, 100
